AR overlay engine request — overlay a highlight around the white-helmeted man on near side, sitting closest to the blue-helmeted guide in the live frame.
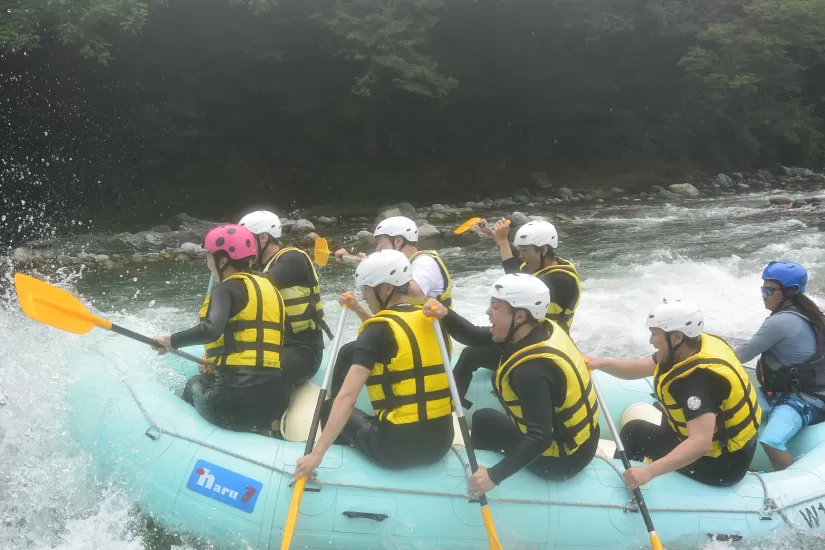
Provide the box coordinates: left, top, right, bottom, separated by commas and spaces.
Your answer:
585, 300, 762, 489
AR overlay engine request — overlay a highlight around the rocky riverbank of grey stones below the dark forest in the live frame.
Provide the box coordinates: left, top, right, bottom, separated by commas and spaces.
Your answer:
12, 167, 825, 269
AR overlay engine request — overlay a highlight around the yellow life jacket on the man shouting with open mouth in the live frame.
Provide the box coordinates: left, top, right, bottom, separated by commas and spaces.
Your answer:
493, 319, 599, 456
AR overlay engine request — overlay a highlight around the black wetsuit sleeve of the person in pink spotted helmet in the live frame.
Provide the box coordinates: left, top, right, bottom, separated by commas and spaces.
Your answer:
172, 279, 243, 349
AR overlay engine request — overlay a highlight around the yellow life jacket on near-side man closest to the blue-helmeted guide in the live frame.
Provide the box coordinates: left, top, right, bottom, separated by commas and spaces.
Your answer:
653, 334, 762, 458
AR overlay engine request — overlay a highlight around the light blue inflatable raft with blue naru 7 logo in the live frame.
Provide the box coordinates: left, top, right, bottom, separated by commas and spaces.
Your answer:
69, 350, 825, 550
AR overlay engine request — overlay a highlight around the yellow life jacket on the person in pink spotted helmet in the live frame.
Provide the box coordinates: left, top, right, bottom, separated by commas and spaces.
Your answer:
200, 273, 284, 369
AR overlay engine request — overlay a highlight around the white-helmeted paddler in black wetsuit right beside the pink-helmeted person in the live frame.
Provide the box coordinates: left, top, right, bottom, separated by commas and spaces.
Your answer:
239, 210, 332, 385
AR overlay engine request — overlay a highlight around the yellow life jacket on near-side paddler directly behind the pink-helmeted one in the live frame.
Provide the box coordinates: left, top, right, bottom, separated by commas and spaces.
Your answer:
358, 308, 453, 424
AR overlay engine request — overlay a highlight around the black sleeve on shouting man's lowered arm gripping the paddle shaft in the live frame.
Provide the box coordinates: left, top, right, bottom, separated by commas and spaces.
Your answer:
487, 359, 566, 485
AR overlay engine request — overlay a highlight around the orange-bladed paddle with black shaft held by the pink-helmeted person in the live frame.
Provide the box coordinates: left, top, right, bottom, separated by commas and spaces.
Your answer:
14, 273, 206, 365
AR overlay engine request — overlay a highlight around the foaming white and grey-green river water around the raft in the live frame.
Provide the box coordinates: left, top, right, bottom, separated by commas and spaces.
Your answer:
0, 192, 825, 550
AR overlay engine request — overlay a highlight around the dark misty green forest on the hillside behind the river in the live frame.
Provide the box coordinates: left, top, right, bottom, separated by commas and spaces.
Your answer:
0, 0, 825, 229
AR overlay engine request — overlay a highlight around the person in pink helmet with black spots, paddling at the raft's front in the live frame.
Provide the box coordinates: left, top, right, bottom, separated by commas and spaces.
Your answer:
154, 225, 292, 433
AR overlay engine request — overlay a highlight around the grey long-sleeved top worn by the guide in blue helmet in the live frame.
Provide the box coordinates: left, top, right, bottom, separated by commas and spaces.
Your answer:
736, 312, 825, 408
